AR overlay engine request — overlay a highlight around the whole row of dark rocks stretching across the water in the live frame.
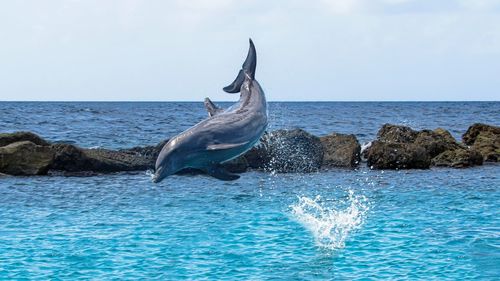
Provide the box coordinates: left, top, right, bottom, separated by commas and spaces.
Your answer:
0, 123, 500, 177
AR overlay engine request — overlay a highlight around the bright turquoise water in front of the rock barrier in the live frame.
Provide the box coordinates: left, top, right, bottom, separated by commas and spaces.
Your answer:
0, 166, 500, 280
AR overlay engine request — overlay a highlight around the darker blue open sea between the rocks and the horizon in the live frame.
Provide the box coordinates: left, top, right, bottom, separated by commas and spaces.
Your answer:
0, 102, 500, 148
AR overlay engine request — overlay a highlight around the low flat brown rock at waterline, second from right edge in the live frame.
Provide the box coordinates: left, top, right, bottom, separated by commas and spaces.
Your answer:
432, 148, 483, 168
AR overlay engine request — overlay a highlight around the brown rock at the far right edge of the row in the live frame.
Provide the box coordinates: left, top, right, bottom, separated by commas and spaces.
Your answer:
462, 123, 500, 162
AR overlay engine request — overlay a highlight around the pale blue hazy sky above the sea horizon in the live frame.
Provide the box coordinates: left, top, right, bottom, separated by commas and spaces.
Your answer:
0, 0, 500, 101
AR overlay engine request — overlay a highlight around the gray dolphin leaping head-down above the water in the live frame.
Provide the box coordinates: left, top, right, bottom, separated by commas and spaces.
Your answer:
153, 39, 267, 182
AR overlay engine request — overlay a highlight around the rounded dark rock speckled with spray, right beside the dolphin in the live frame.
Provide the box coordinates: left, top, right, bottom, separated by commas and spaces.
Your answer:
245, 129, 323, 173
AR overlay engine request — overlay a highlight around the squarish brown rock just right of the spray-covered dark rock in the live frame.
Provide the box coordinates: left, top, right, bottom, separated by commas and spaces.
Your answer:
320, 133, 361, 167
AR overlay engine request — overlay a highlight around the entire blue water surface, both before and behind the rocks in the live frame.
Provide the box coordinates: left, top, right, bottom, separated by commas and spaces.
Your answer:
0, 102, 500, 280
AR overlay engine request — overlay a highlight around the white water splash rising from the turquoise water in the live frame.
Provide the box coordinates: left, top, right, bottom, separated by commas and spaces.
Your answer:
290, 190, 369, 250
